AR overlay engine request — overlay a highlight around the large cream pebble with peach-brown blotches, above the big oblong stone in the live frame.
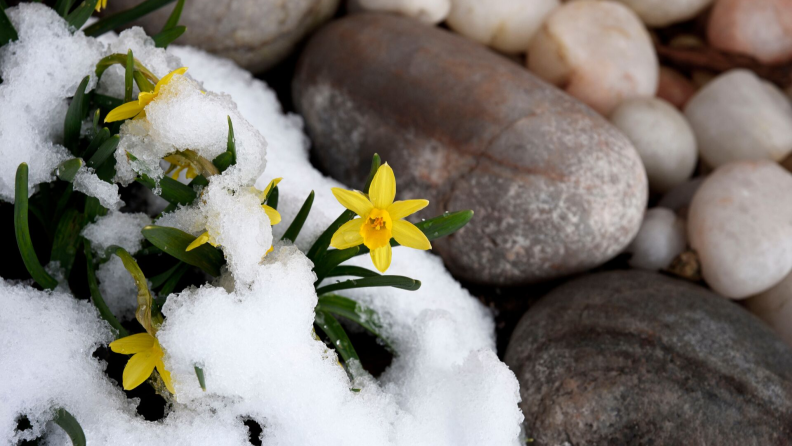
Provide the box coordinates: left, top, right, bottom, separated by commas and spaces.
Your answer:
528, 1, 659, 116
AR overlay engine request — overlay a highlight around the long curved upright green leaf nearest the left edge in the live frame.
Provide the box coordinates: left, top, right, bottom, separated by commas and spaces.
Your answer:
14, 163, 58, 290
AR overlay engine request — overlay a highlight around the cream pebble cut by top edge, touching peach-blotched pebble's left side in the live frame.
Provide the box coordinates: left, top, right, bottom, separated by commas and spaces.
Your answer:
448, 0, 561, 54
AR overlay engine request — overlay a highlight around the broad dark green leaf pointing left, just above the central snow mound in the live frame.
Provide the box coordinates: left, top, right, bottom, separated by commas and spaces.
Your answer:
142, 225, 225, 277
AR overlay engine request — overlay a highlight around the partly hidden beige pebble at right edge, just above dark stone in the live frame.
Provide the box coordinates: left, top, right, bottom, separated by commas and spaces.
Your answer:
745, 274, 792, 345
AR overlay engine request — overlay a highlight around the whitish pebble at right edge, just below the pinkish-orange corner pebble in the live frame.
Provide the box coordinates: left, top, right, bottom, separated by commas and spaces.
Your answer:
685, 69, 792, 167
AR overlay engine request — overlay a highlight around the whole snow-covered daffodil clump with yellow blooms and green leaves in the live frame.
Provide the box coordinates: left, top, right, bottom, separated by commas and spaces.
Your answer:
0, 0, 522, 445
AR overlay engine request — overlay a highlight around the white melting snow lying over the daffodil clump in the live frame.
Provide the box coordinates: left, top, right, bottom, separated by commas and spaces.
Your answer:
0, 5, 523, 446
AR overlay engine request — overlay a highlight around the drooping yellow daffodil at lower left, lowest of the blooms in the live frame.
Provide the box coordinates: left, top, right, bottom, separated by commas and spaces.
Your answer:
110, 333, 176, 395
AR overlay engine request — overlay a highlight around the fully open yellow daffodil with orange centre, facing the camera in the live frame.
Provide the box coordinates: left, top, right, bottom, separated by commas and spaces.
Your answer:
330, 163, 432, 273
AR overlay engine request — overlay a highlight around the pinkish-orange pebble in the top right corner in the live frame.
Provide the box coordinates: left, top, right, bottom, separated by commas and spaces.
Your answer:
707, 0, 792, 64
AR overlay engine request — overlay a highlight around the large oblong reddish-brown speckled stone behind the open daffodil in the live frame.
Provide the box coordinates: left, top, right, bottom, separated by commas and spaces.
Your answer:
293, 14, 647, 285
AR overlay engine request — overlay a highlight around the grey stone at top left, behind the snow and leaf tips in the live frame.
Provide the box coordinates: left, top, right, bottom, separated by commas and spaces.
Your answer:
107, 0, 339, 73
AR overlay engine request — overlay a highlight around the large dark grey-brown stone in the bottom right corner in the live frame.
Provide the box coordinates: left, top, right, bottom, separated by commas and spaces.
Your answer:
505, 271, 792, 446
